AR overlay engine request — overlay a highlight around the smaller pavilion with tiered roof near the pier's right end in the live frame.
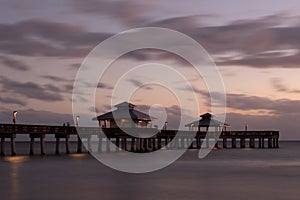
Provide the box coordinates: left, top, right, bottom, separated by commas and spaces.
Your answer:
185, 113, 230, 131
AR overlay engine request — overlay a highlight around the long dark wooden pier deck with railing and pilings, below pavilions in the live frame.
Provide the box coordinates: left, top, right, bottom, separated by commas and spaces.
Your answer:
0, 124, 279, 155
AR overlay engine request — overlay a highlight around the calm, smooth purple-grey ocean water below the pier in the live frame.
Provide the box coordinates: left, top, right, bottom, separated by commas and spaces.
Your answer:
0, 142, 300, 200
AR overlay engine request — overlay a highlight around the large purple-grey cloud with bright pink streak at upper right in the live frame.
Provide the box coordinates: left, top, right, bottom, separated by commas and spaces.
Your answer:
140, 15, 300, 68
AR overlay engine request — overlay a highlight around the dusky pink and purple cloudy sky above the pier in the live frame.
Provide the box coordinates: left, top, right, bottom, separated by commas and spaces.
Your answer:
0, 0, 300, 140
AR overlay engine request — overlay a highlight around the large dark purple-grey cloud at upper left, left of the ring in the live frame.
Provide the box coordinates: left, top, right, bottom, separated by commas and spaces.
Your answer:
0, 20, 110, 57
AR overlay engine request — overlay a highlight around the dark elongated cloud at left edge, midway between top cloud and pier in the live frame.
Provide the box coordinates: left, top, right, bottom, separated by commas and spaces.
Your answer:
0, 76, 63, 101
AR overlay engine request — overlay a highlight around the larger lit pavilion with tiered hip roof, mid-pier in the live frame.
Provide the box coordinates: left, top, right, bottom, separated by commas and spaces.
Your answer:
94, 102, 151, 128
